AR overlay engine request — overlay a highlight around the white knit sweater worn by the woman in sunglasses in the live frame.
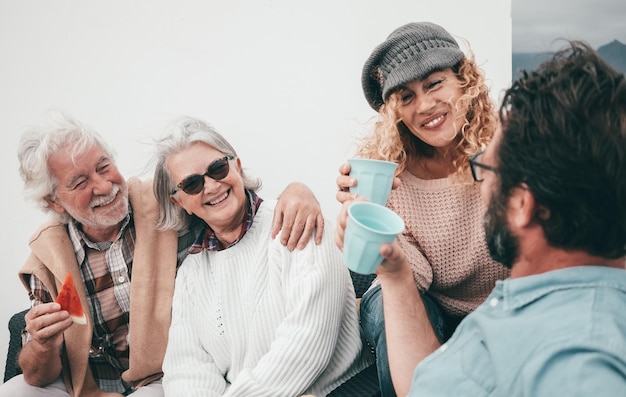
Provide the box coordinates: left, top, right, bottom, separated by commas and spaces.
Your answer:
163, 201, 371, 397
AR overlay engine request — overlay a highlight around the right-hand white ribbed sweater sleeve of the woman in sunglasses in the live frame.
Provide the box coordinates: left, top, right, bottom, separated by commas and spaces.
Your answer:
225, 226, 352, 397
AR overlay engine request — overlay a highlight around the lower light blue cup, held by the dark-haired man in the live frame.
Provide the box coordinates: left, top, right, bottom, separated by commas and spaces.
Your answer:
343, 201, 404, 274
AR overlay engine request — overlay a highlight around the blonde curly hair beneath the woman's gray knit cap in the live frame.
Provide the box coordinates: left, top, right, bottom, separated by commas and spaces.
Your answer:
357, 52, 498, 175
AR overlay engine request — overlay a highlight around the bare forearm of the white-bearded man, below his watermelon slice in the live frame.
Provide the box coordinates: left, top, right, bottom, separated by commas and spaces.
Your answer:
19, 341, 62, 387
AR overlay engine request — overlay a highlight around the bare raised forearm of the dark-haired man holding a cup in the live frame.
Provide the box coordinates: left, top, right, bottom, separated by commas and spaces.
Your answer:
379, 266, 440, 396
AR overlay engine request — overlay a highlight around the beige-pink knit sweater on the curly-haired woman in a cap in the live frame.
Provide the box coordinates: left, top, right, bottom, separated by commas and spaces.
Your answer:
378, 171, 509, 315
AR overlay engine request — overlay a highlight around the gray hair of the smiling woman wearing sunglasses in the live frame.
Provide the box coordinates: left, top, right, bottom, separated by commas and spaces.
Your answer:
153, 116, 262, 230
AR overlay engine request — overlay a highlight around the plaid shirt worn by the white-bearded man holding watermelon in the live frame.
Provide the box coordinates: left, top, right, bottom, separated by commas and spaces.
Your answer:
30, 215, 135, 393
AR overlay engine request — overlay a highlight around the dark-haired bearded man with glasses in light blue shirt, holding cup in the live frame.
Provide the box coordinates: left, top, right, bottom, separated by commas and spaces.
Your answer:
338, 41, 626, 397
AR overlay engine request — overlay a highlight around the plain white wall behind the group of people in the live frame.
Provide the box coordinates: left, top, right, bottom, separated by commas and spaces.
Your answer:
0, 0, 511, 368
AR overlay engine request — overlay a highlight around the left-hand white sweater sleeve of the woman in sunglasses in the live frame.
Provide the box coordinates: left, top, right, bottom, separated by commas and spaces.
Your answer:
163, 256, 226, 397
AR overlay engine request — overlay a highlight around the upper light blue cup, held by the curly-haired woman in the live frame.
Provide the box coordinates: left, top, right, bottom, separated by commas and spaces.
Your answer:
348, 158, 398, 205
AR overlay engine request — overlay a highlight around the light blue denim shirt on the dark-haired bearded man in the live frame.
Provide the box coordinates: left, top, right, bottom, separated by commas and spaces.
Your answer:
409, 266, 626, 397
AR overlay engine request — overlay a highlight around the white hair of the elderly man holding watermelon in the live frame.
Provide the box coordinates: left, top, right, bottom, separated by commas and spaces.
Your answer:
17, 110, 113, 223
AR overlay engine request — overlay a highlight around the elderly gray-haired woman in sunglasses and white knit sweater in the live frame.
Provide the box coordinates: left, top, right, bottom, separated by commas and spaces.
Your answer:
154, 118, 372, 397
